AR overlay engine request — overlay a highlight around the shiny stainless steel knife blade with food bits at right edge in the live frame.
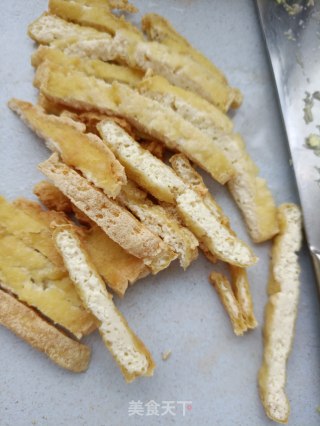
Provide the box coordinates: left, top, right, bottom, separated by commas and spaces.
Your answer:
257, 0, 320, 291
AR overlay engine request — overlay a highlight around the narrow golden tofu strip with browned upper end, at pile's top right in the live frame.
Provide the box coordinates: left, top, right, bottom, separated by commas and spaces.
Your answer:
141, 13, 227, 83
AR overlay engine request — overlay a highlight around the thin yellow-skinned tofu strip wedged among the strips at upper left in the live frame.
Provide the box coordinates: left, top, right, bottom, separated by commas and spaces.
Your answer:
31, 46, 144, 86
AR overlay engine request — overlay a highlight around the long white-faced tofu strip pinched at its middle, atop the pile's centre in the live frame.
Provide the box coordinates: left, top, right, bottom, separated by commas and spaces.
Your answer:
98, 121, 257, 267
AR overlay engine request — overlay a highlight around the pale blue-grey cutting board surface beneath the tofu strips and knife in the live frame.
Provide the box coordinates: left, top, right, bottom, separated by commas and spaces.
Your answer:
0, 0, 320, 426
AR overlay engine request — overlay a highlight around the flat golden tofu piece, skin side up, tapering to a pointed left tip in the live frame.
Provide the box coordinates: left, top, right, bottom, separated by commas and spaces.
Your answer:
9, 99, 126, 198
